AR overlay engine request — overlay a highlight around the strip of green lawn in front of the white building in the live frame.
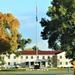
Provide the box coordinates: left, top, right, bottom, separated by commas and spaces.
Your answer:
0, 68, 73, 74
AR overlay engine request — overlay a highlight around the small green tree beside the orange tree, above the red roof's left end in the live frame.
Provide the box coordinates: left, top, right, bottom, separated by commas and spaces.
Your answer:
17, 33, 32, 50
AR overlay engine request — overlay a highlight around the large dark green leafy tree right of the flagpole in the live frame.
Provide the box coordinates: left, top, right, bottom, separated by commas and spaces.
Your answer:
40, 0, 75, 74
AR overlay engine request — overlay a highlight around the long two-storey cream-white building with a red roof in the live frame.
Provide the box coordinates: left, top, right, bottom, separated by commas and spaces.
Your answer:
4, 51, 72, 68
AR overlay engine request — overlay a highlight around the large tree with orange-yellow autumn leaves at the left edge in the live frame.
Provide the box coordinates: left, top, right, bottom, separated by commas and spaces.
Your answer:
0, 12, 19, 52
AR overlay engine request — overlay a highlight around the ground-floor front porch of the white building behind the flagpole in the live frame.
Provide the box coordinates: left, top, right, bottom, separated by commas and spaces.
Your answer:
20, 60, 47, 69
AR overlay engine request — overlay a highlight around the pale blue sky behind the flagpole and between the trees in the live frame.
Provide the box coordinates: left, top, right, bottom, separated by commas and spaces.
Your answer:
0, 0, 51, 50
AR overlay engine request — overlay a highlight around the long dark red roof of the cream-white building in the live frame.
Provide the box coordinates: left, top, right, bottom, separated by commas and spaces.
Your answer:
20, 50, 62, 55
